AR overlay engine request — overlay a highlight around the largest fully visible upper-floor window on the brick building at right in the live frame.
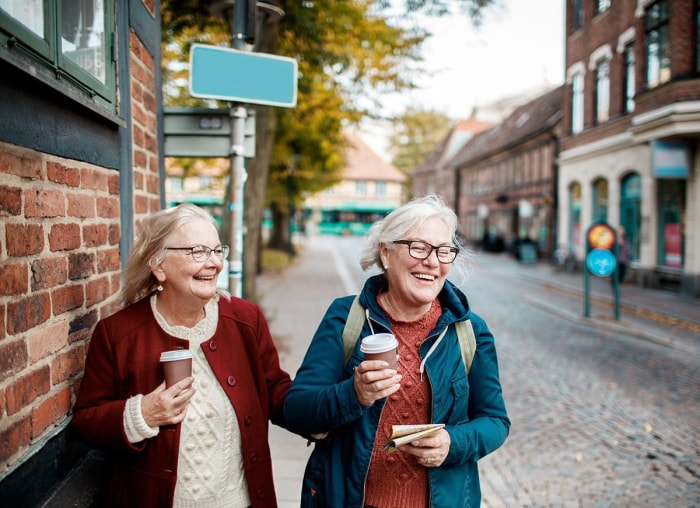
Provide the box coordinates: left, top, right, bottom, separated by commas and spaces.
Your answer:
645, 0, 671, 88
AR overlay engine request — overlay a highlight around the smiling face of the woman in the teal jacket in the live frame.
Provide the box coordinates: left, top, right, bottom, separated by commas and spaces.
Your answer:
380, 217, 452, 315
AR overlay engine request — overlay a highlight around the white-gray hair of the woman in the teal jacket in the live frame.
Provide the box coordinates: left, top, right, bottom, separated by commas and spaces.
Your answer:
360, 194, 471, 279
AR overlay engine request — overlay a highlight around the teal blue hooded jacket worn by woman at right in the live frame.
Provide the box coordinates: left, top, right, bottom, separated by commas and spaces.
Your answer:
284, 275, 510, 508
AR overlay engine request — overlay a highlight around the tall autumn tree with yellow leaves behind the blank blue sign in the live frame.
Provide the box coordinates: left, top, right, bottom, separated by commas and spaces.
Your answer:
162, 0, 493, 297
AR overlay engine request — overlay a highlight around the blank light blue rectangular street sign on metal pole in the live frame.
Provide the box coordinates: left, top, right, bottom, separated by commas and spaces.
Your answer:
190, 44, 298, 108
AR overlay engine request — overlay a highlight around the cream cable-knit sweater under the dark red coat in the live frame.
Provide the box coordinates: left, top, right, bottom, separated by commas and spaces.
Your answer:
124, 295, 251, 508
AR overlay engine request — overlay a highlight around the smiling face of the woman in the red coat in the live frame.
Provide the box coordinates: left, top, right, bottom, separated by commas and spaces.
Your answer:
152, 218, 224, 311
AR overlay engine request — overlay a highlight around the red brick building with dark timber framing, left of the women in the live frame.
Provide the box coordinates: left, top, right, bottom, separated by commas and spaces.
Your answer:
0, 0, 163, 506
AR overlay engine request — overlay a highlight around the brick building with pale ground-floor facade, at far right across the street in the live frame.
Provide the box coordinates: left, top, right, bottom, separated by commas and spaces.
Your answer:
558, 0, 700, 297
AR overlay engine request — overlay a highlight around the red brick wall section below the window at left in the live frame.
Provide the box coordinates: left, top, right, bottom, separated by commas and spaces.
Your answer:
0, 143, 120, 473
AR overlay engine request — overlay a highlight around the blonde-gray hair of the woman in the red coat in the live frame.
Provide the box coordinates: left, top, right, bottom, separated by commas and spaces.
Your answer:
122, 203, 216, 305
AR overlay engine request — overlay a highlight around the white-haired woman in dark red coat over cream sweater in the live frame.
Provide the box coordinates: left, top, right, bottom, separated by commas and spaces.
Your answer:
72, 204, 291, 508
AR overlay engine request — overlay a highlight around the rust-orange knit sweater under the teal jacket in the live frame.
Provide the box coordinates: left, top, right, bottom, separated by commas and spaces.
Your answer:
365, 299, 442, 508
